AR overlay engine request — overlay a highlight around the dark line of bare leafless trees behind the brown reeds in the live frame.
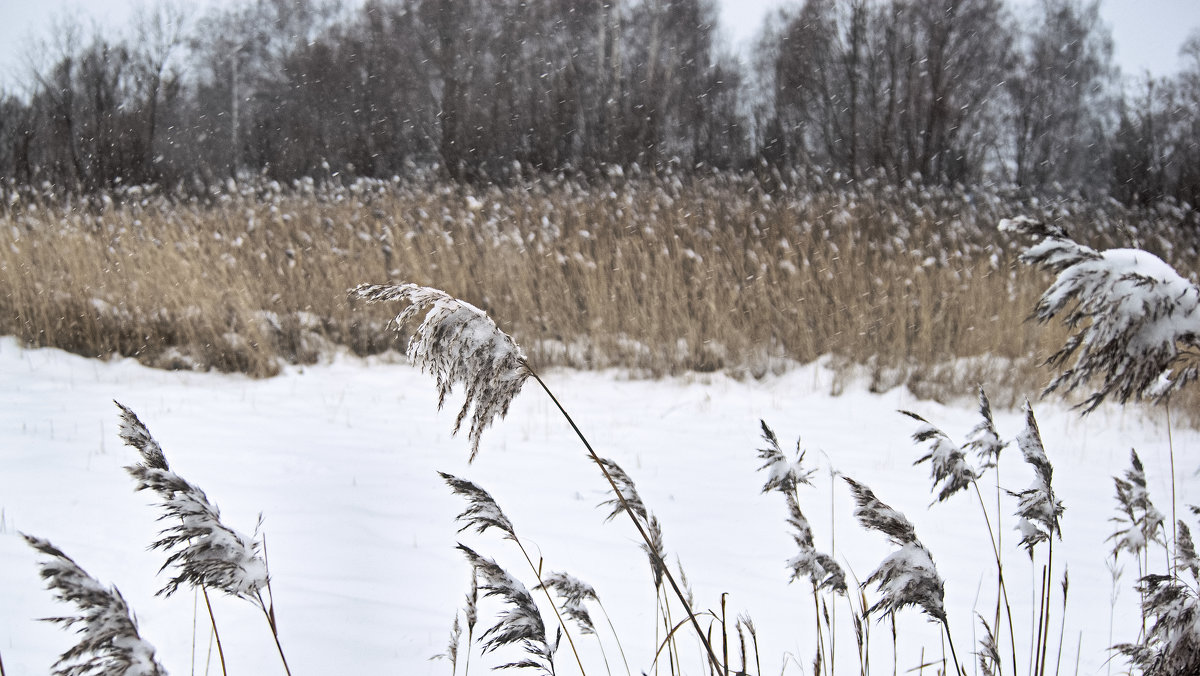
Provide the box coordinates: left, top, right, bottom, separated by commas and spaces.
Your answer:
0, 0, 1200, 204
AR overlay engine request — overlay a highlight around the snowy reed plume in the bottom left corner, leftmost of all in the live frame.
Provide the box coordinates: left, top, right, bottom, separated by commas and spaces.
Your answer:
22, 534, 167, 676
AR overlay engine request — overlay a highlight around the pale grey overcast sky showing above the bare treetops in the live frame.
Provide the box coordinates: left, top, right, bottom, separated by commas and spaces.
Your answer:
0, 0, 1200, 86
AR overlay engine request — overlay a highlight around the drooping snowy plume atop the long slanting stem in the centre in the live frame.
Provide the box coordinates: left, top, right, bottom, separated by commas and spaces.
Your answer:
350, 283, 530, 460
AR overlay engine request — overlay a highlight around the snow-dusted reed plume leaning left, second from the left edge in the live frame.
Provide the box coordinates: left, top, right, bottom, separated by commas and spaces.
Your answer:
116, 402, 268, 597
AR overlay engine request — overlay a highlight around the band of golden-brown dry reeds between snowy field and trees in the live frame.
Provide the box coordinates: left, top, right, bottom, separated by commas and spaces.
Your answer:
0, 174, 1196, 403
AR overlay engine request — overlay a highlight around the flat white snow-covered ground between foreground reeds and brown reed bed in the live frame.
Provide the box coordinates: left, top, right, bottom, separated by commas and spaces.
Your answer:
0, 339, 1200, 675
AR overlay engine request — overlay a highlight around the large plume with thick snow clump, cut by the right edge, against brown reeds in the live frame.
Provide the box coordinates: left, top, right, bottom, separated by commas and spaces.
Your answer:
1000, 216, 1200, 411
